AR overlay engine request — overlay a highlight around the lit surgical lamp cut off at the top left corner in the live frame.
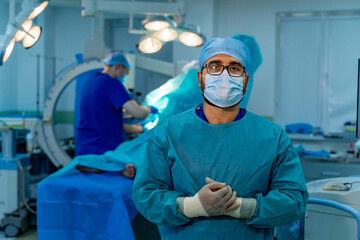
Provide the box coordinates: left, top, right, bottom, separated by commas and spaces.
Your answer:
0, 0, 49, 65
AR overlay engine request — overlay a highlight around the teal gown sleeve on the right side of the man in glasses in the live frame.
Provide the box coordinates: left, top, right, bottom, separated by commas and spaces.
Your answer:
246, 130, 309, 228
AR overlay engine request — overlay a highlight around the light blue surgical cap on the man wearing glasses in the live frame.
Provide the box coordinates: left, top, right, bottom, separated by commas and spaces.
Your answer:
199, 37, 251, 72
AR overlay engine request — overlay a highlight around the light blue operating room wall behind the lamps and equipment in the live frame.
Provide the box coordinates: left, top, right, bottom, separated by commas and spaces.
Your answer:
0, 0, 360, 119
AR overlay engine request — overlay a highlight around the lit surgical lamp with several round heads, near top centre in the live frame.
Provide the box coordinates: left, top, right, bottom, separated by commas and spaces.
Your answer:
139, 16, 205, 54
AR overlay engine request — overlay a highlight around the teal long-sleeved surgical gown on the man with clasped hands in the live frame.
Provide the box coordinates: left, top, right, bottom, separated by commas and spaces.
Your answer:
133, 108, 308, 239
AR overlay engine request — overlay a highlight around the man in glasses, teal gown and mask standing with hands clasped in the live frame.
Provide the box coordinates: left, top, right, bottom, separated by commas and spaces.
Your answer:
133, 38, 308, 239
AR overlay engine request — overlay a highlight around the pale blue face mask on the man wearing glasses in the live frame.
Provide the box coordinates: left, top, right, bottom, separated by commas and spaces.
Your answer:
204, 71, 244, 107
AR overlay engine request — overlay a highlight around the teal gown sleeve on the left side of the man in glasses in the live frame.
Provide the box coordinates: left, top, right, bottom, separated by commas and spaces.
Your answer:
132, 124, 190, 226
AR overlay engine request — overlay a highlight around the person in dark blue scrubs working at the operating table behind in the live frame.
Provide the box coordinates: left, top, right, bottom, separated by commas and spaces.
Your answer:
76, 53, 157, 177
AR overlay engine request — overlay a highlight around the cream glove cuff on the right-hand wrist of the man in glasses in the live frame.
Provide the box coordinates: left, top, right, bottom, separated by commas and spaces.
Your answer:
225, 197, 257, 219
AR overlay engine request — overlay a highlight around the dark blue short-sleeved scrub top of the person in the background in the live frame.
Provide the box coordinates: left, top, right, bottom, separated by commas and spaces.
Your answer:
76, 72, 132, 155
